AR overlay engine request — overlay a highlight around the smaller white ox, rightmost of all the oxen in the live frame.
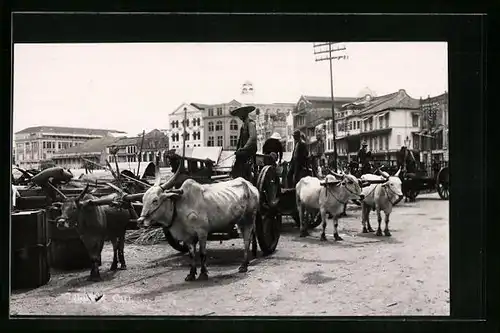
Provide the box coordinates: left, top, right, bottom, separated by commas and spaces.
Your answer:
361, 169, 403, 236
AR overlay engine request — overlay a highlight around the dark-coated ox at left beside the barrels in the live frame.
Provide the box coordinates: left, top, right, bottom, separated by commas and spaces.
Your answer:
53, 185, 129, 281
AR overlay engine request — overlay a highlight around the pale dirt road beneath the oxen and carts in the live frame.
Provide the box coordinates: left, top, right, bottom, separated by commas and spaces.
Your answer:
10, 194, 450, 316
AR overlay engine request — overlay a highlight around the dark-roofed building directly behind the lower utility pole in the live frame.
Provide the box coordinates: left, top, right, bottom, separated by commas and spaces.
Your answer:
293, 96, 356, 153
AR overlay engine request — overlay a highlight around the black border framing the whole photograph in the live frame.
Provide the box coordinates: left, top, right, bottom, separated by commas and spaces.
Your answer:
1, 6, 494, 332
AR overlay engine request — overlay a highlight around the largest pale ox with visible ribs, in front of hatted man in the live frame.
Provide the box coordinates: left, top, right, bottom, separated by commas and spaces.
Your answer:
137, 172, 259, 281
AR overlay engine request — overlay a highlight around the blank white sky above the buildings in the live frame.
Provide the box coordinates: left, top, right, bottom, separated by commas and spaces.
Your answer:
14, 42, 448, 135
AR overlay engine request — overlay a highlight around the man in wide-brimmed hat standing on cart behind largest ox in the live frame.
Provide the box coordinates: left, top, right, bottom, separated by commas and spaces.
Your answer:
231, 106, 257, 182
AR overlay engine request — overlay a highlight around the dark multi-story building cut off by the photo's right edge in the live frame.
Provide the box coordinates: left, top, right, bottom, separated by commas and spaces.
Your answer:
413, 92, 449, 164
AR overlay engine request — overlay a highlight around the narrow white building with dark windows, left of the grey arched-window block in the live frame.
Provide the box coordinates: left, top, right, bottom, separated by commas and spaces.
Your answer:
167, 103, 205, 149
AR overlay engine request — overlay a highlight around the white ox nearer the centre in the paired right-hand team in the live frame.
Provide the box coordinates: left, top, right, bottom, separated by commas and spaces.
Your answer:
295, 174, 363, 241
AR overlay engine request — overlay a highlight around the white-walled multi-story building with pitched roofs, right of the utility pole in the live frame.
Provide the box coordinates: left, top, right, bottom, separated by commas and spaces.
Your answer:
332, 89, 421, 160
